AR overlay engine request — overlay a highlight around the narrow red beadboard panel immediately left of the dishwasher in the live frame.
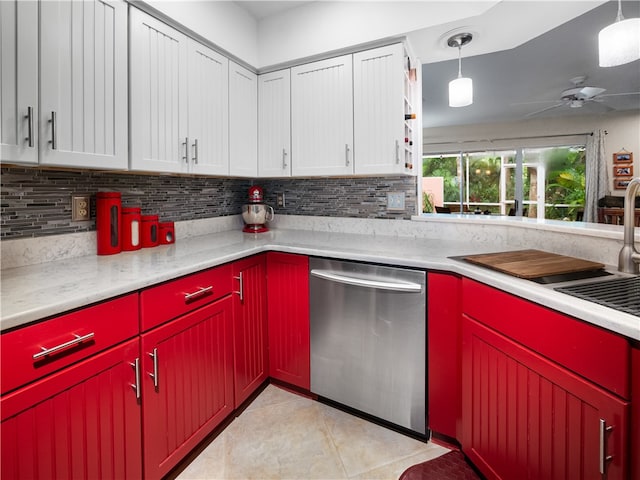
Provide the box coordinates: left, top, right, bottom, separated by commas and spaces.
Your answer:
267, 252, 311, 390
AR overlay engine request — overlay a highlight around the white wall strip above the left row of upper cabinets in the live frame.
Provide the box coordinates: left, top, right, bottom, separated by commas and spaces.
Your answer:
146, 0, 258, 67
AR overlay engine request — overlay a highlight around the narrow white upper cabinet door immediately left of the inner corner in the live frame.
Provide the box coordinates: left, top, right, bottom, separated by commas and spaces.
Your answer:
229, 62, 258, 178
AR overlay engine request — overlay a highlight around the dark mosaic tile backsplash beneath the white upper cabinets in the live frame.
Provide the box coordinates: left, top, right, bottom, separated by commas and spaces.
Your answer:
0, 166, 416, 239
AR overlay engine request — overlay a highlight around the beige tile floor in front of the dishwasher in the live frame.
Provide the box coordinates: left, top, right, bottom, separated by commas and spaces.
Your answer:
177, 385, 449, 480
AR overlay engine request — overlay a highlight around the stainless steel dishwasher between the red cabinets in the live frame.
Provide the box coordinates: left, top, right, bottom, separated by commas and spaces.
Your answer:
309, 258, 426, 435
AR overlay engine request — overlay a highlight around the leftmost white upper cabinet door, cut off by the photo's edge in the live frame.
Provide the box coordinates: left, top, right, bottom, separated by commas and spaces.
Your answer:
0, 0, 38, 163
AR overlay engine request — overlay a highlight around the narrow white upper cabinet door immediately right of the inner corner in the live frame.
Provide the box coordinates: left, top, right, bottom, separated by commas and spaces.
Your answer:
258, 68, 292, 178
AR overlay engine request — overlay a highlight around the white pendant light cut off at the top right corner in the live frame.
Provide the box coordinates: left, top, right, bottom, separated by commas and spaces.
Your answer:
598, 0, 640, 67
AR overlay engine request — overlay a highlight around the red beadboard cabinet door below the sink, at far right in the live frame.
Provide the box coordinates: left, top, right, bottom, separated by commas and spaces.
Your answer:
462, 316, 629, 480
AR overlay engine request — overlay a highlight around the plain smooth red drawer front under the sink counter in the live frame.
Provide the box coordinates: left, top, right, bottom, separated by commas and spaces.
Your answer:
462, 278, 631, 398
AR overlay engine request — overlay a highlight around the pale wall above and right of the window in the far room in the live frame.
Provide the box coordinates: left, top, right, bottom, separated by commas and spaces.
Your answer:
423, 111, 640, 196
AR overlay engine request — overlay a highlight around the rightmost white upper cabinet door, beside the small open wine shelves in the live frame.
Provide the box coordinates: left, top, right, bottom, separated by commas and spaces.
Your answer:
353, 44, 405, 175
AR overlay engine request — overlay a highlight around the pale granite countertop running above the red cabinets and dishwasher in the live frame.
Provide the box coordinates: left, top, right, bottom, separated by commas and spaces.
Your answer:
0, 229, 640, 340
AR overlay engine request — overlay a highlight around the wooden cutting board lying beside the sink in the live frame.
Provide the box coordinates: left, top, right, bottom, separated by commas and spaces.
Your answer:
464, 250, 604, 279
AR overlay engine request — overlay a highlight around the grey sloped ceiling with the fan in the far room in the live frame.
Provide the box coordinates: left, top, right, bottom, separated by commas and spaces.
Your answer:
422, 1, 640, 127
